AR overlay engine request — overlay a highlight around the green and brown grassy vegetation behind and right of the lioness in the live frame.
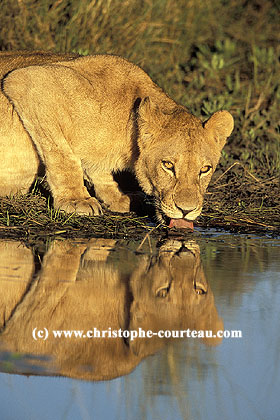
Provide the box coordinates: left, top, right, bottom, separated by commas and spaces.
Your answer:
0, 0, 280, 236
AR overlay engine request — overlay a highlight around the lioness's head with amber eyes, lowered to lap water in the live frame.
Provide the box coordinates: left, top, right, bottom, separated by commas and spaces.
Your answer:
135, 98, 234, 221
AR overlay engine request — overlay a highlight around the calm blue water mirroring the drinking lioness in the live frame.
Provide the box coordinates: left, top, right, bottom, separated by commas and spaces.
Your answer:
0, 232, 280, 420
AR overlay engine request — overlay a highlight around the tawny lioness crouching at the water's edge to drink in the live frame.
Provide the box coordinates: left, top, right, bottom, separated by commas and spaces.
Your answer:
0, 53, 233, 226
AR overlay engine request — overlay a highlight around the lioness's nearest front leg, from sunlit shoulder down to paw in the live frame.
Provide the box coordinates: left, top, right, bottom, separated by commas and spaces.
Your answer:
4, 66, 102, 215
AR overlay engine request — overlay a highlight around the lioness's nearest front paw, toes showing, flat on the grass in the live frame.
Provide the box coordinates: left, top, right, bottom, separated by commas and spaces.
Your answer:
55, 197, 103, 216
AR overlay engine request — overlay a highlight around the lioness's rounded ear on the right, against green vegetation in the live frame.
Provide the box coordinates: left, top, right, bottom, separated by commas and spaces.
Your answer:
204, 111, 234, 147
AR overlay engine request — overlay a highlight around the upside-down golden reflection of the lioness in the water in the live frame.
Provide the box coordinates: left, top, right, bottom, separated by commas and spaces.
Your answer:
0, 239, 223, 380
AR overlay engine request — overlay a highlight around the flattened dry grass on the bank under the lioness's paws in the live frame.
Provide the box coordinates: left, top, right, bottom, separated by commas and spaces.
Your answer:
0, 191, 164, 240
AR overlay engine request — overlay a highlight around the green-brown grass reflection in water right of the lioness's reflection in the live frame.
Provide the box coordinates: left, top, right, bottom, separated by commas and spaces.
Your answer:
198, 234, 279, 306
